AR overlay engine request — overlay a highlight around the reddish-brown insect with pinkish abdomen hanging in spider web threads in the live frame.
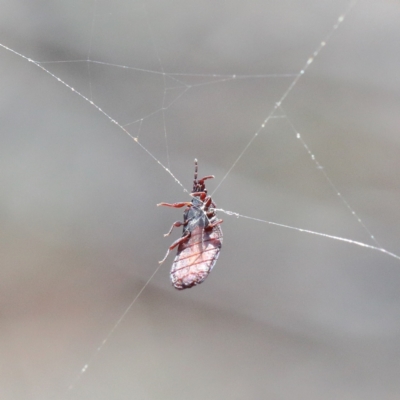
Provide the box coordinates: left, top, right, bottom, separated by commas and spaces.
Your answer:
157, 159, 222, 290
